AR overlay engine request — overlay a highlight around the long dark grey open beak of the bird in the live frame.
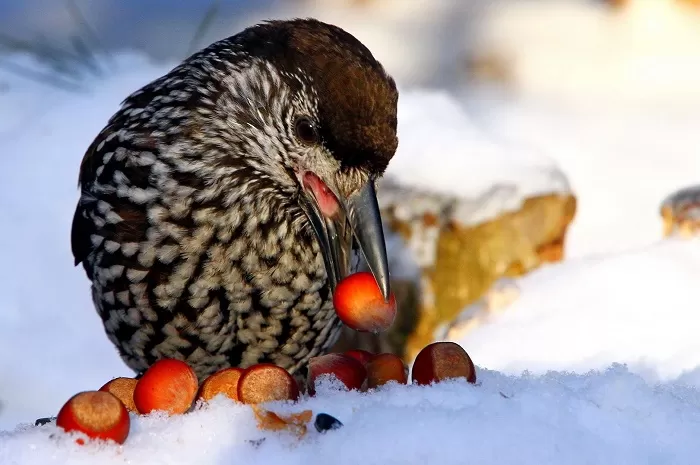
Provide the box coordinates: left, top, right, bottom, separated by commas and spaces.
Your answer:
306, 180, 391, 301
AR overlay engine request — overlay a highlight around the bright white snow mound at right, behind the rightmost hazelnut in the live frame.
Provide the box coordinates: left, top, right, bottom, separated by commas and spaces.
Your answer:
457, 239, 700, 386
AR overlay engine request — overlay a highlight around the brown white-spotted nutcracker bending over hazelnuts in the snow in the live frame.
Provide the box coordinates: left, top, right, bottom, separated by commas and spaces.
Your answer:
71, 18, 398, 380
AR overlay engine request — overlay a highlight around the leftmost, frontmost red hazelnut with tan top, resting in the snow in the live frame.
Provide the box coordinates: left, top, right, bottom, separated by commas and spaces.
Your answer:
56, 391, 131, 445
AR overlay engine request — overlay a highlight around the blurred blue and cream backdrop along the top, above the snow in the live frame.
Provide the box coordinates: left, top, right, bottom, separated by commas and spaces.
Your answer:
0, 0, 700, 102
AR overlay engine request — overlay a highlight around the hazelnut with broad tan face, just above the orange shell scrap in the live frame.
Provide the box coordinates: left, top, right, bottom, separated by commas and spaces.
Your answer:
238, 363, 299, 404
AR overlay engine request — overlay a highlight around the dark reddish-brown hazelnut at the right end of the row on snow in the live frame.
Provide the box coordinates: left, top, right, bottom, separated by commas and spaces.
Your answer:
411, 342, 476, 384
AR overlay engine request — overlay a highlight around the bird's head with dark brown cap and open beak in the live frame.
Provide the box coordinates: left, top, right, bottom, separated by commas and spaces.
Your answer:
193, 20, 398, 298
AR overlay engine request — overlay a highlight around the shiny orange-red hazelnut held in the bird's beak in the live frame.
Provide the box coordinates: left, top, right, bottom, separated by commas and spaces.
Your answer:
333, 271, 396, 333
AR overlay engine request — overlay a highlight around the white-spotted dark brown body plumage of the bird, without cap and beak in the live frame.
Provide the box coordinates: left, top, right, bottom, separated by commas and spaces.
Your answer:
72, 18, 395, 378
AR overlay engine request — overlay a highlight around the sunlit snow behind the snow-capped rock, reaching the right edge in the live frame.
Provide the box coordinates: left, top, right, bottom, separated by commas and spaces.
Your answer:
469, 97, 700, 258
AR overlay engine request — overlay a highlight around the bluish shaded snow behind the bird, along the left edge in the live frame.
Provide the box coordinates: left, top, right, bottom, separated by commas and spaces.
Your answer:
0, 56, 165, 436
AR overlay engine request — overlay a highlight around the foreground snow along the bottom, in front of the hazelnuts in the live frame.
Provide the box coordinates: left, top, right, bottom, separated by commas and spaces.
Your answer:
0, 366, 700, 465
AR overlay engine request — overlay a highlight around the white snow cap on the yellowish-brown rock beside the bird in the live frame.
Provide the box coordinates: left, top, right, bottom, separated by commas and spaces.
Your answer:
386, 90, 570, 225
